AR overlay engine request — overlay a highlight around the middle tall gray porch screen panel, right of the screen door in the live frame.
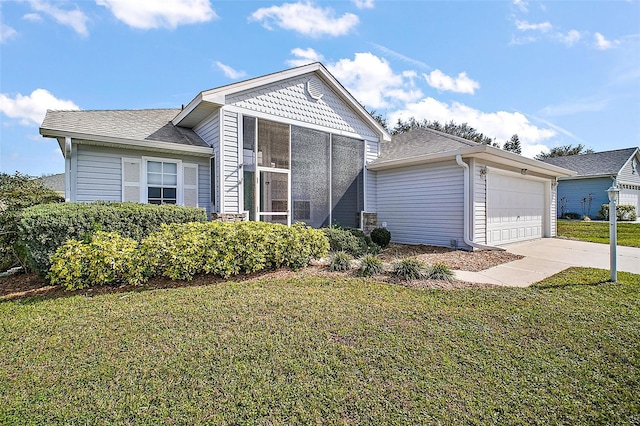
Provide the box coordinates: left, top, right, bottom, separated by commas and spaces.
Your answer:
291, 126, 331, 228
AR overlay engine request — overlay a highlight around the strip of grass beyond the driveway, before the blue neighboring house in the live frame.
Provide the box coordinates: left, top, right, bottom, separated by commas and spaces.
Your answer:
558, 220, 640, 247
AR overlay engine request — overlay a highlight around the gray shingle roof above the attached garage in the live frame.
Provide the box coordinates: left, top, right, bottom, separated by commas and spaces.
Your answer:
377, 128, 478, 161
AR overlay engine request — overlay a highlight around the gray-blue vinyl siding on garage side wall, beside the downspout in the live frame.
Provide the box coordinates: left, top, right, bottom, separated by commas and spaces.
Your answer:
377, 162, 464, 247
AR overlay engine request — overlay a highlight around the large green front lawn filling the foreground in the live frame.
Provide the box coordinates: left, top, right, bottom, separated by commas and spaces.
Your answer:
0, 269, 640, 425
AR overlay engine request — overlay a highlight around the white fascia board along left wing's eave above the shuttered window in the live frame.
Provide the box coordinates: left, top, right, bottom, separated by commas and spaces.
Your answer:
40, 128, 213, 157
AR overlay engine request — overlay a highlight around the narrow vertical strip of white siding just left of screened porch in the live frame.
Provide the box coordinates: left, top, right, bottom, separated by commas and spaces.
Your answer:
221, 110, 240, 213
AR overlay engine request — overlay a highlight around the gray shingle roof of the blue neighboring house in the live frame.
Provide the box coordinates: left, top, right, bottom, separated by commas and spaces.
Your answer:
542, 148, 638, 177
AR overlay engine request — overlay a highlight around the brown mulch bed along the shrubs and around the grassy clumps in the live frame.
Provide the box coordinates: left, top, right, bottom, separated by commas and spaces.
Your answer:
0, 244, 522, 301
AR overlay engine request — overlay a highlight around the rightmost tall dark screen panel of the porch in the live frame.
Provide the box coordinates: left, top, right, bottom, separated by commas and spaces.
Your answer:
331, 135, 364, 228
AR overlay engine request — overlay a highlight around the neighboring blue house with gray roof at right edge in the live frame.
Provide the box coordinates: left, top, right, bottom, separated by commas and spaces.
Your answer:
544, 148, 640, 219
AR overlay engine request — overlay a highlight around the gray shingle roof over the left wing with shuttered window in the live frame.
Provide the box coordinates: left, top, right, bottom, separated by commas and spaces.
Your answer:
41, 109, 209, 147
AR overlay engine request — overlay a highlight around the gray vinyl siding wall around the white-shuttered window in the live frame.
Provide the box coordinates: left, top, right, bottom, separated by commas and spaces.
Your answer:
72, 145, 210, 213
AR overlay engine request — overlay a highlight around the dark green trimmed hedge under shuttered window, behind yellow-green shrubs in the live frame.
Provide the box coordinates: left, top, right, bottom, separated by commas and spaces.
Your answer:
18, 202, 207, 275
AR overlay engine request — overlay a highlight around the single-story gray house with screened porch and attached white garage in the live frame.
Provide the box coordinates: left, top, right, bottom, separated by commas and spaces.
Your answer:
40, 63, 571, 249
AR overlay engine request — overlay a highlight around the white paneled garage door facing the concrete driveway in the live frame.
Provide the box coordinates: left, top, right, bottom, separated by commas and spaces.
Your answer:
487, 173, 545, 245
